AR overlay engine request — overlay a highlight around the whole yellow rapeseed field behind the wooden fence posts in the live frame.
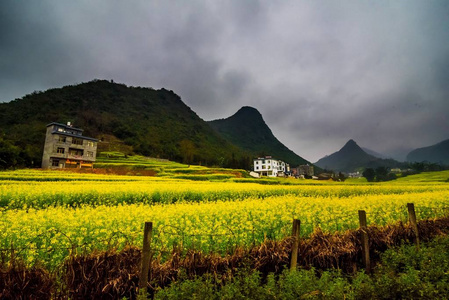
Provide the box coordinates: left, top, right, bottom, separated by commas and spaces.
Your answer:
0, 171, 449, 267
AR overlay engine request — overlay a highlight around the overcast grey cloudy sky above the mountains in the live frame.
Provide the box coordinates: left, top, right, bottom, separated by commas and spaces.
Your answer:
0, 0, 449, 162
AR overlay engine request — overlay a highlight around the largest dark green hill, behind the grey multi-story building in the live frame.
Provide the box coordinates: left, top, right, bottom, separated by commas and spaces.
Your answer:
0, 80, 252, 168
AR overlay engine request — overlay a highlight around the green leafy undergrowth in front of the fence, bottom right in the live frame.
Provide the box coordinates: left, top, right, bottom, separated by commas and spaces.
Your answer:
154, 237, 449, 300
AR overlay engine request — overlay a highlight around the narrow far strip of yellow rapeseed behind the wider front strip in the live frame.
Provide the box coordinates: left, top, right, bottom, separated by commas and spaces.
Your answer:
0, 180, 447, 210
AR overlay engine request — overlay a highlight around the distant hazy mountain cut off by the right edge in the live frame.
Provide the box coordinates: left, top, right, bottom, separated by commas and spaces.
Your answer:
407, 140, 449, 165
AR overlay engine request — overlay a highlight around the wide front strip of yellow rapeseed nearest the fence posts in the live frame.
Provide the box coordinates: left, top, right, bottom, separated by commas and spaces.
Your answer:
0, 190, 449, 267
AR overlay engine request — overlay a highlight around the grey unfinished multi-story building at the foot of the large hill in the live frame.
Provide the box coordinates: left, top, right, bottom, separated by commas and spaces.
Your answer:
42, 122, 98, 169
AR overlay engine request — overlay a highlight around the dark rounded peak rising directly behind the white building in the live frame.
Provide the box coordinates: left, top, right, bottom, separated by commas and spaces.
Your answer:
209, 106, 310, 166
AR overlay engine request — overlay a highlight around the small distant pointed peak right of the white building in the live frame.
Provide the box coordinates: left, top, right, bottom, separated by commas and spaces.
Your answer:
315, 140, 403, 172
